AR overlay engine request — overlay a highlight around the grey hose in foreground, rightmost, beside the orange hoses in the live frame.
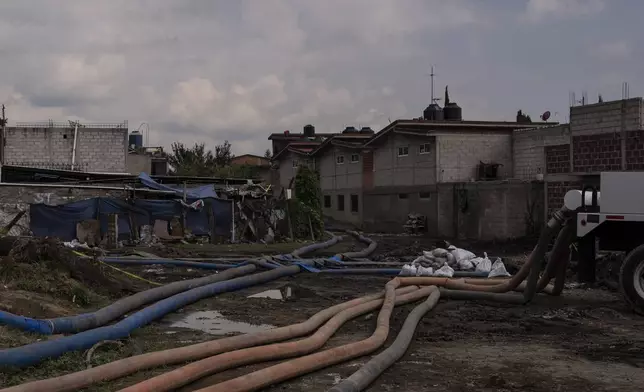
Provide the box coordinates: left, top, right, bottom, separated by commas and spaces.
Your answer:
328, 286, 440, 392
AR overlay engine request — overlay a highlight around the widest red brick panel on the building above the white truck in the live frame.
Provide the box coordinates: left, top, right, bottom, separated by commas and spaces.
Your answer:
572, 132, 622, 173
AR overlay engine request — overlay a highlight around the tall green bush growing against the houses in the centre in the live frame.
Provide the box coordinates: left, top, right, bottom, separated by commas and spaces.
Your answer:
289, 165, 324, 238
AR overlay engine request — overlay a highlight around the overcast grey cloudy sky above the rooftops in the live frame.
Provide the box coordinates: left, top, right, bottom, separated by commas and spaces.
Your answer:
0, 0, 644, 154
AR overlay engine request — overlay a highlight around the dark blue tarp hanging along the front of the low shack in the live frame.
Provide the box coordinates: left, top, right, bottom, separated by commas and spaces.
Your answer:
29, 197, 232, 241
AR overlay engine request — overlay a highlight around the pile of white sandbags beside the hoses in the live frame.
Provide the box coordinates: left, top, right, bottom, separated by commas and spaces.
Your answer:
400, 245, 510, 278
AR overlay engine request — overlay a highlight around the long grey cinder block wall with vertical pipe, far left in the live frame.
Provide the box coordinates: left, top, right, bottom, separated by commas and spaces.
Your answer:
4, 127, 128, 173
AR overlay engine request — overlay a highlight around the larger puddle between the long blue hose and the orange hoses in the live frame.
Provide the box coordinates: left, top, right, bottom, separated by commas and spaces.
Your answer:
170, 310, 273, 335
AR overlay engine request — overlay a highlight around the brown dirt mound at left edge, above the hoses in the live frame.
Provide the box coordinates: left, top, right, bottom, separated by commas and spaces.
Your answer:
0, 238, 141, 306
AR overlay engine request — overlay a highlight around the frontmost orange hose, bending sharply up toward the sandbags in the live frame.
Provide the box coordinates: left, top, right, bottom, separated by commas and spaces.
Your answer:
199, 278, 406, 392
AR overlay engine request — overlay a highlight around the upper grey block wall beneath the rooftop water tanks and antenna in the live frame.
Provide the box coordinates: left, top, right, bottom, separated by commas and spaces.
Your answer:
436, 133, 513, 182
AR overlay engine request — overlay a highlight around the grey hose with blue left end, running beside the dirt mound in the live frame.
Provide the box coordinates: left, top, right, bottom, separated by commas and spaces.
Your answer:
0, 265, 256, 335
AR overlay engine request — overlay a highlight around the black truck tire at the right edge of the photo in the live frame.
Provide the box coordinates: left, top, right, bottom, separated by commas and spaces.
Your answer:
619, 245, 644, 315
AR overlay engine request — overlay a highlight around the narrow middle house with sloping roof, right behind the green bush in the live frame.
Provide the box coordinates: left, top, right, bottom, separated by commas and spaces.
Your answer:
309, 127, 374, 224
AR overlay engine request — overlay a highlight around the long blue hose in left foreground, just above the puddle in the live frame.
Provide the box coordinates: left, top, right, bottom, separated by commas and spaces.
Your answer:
0, 265, 300, 368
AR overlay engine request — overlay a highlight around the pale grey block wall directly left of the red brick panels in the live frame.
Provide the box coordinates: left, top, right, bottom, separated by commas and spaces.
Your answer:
512, 125, 570, 181
